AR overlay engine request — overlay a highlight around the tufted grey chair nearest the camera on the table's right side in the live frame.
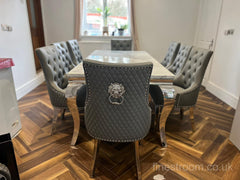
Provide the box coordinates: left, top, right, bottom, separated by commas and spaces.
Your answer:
149, 47, 213, 130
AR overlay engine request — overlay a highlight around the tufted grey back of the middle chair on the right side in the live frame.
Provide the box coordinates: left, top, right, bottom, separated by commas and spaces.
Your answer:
168, 44, 192, 75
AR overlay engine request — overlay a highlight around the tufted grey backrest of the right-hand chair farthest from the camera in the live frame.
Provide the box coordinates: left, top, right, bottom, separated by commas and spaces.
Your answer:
161, 42, 180, 67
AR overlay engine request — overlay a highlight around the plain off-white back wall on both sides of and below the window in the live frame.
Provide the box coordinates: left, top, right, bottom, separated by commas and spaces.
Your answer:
42, 0, 199, 61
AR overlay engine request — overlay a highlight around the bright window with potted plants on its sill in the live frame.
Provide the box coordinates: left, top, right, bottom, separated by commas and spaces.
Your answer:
81, 0, 131, 36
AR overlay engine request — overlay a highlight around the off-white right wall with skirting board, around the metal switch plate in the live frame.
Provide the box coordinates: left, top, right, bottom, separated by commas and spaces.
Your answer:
204, 0, 240, 108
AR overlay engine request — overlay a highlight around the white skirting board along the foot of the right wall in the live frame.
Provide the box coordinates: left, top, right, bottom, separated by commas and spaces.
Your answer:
203, 81, 238, 109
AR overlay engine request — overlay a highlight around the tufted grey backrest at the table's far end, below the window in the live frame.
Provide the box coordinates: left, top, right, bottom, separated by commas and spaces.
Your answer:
111, 39, 132, 51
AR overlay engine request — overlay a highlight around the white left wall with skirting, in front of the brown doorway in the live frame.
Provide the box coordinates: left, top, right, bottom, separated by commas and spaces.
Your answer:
0, 0, 43, 99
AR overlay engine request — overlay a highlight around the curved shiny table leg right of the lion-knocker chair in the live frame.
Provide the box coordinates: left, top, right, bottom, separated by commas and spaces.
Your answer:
159, 98, 175, 147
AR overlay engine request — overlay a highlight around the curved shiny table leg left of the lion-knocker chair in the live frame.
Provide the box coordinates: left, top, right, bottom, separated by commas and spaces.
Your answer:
65, 81, 81, 146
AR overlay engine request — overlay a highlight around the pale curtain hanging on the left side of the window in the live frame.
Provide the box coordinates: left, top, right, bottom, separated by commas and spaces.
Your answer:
74, 0, 83, 40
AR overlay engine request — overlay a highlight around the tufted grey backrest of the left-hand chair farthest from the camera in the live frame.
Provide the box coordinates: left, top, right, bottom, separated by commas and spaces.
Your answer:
67, 39, 82, 65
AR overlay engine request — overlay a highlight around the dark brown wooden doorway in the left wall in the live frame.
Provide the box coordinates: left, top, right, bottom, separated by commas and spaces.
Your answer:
27, 0, 45, 71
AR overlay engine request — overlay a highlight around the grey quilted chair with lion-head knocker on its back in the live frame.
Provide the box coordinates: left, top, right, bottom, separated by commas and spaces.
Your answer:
83, 60, 153, 179
